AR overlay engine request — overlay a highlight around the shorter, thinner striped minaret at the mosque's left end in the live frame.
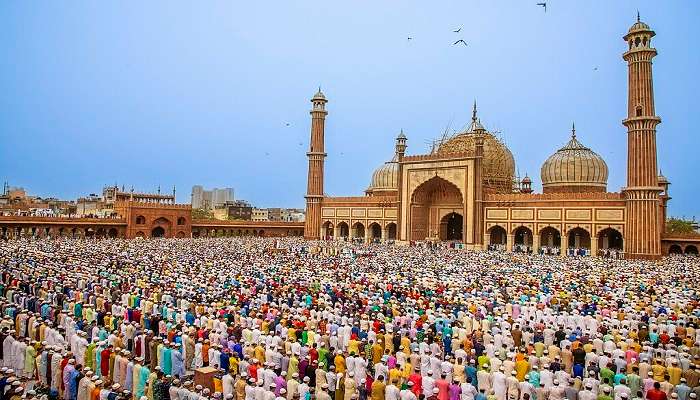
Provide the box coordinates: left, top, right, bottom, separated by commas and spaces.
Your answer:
304, 88, 328, 240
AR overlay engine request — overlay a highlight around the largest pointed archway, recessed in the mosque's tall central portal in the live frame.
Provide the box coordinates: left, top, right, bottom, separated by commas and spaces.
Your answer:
408, 176, 464, 240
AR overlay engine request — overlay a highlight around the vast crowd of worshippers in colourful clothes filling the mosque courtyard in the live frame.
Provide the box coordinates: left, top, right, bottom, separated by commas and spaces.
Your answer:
0, 238, 700, 400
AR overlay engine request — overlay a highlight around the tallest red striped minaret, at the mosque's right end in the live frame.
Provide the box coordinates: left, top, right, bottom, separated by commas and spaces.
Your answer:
622, 13, 663, 260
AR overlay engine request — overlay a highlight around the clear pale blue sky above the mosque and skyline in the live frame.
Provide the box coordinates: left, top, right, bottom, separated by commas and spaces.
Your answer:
0, 0, 700, 217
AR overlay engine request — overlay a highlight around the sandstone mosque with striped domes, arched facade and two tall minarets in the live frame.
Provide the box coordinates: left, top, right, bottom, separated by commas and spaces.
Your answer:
305, 19, 684, 259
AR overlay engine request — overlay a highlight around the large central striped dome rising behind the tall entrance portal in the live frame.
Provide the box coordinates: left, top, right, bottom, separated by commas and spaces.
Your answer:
434, 103, 515, 193
